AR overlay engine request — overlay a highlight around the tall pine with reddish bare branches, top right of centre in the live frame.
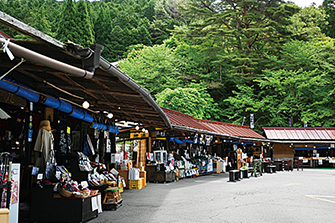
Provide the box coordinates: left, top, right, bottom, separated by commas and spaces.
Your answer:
183, 0, 299, 84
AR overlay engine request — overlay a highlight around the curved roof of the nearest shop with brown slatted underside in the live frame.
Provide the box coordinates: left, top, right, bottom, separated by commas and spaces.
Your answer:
0, 11, 171, 128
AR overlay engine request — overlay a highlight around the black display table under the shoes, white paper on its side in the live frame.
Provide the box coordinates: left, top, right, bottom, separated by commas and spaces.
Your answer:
30, 185, 101, 223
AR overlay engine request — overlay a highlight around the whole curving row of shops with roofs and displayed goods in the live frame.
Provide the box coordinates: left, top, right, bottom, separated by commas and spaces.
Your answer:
0, 12, 335, 223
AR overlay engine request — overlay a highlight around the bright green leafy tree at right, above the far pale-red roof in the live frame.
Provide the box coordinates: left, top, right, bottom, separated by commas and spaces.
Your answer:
226, 39, 335, 129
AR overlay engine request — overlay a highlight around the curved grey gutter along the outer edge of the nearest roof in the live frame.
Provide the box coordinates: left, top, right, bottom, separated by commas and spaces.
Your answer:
99, 57, 172, 129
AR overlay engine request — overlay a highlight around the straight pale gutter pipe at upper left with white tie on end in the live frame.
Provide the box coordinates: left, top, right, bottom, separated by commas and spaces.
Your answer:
0, 38, 94, 78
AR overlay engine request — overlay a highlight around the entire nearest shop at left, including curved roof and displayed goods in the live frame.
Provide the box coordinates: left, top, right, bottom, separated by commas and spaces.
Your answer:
0, 15, 169, 223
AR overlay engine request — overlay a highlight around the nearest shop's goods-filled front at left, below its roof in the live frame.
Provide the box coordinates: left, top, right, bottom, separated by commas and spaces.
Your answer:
0, 90, 122, 222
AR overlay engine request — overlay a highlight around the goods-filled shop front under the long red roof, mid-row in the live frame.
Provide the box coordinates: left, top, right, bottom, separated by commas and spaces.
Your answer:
146, 130, 225, 182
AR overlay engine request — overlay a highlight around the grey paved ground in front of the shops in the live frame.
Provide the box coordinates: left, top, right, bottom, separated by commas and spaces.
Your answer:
89, 169, 335, 223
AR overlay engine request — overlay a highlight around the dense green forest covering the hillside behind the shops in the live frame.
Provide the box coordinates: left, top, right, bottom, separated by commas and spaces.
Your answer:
0, 0, 335, 131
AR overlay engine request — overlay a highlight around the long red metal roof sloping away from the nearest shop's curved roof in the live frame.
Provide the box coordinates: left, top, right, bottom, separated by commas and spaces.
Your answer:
162, 108, 265, 139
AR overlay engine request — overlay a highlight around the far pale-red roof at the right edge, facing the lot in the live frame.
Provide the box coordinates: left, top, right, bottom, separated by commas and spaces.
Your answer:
263, 127, 335, 140
